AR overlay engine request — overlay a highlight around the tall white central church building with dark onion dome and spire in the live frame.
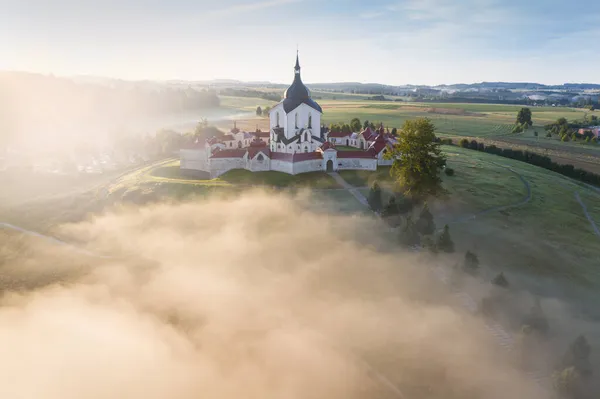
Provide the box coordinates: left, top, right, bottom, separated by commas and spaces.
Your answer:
269, 53, 323, 153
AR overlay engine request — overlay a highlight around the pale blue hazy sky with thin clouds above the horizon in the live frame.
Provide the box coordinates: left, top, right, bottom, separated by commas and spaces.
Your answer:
0, 0, 600, 85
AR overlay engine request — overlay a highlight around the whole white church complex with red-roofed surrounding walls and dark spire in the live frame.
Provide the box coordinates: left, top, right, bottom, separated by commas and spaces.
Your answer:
180, 55, 396, 178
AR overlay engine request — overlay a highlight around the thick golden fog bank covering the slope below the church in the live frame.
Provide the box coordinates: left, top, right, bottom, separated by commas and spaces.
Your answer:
0, 193, 544, 399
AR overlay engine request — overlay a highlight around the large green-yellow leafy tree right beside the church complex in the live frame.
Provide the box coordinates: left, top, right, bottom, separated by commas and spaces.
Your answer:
388, 118, 446, 202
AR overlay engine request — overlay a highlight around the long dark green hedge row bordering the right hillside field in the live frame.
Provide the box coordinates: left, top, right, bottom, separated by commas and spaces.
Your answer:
459, 139, 600, 187
